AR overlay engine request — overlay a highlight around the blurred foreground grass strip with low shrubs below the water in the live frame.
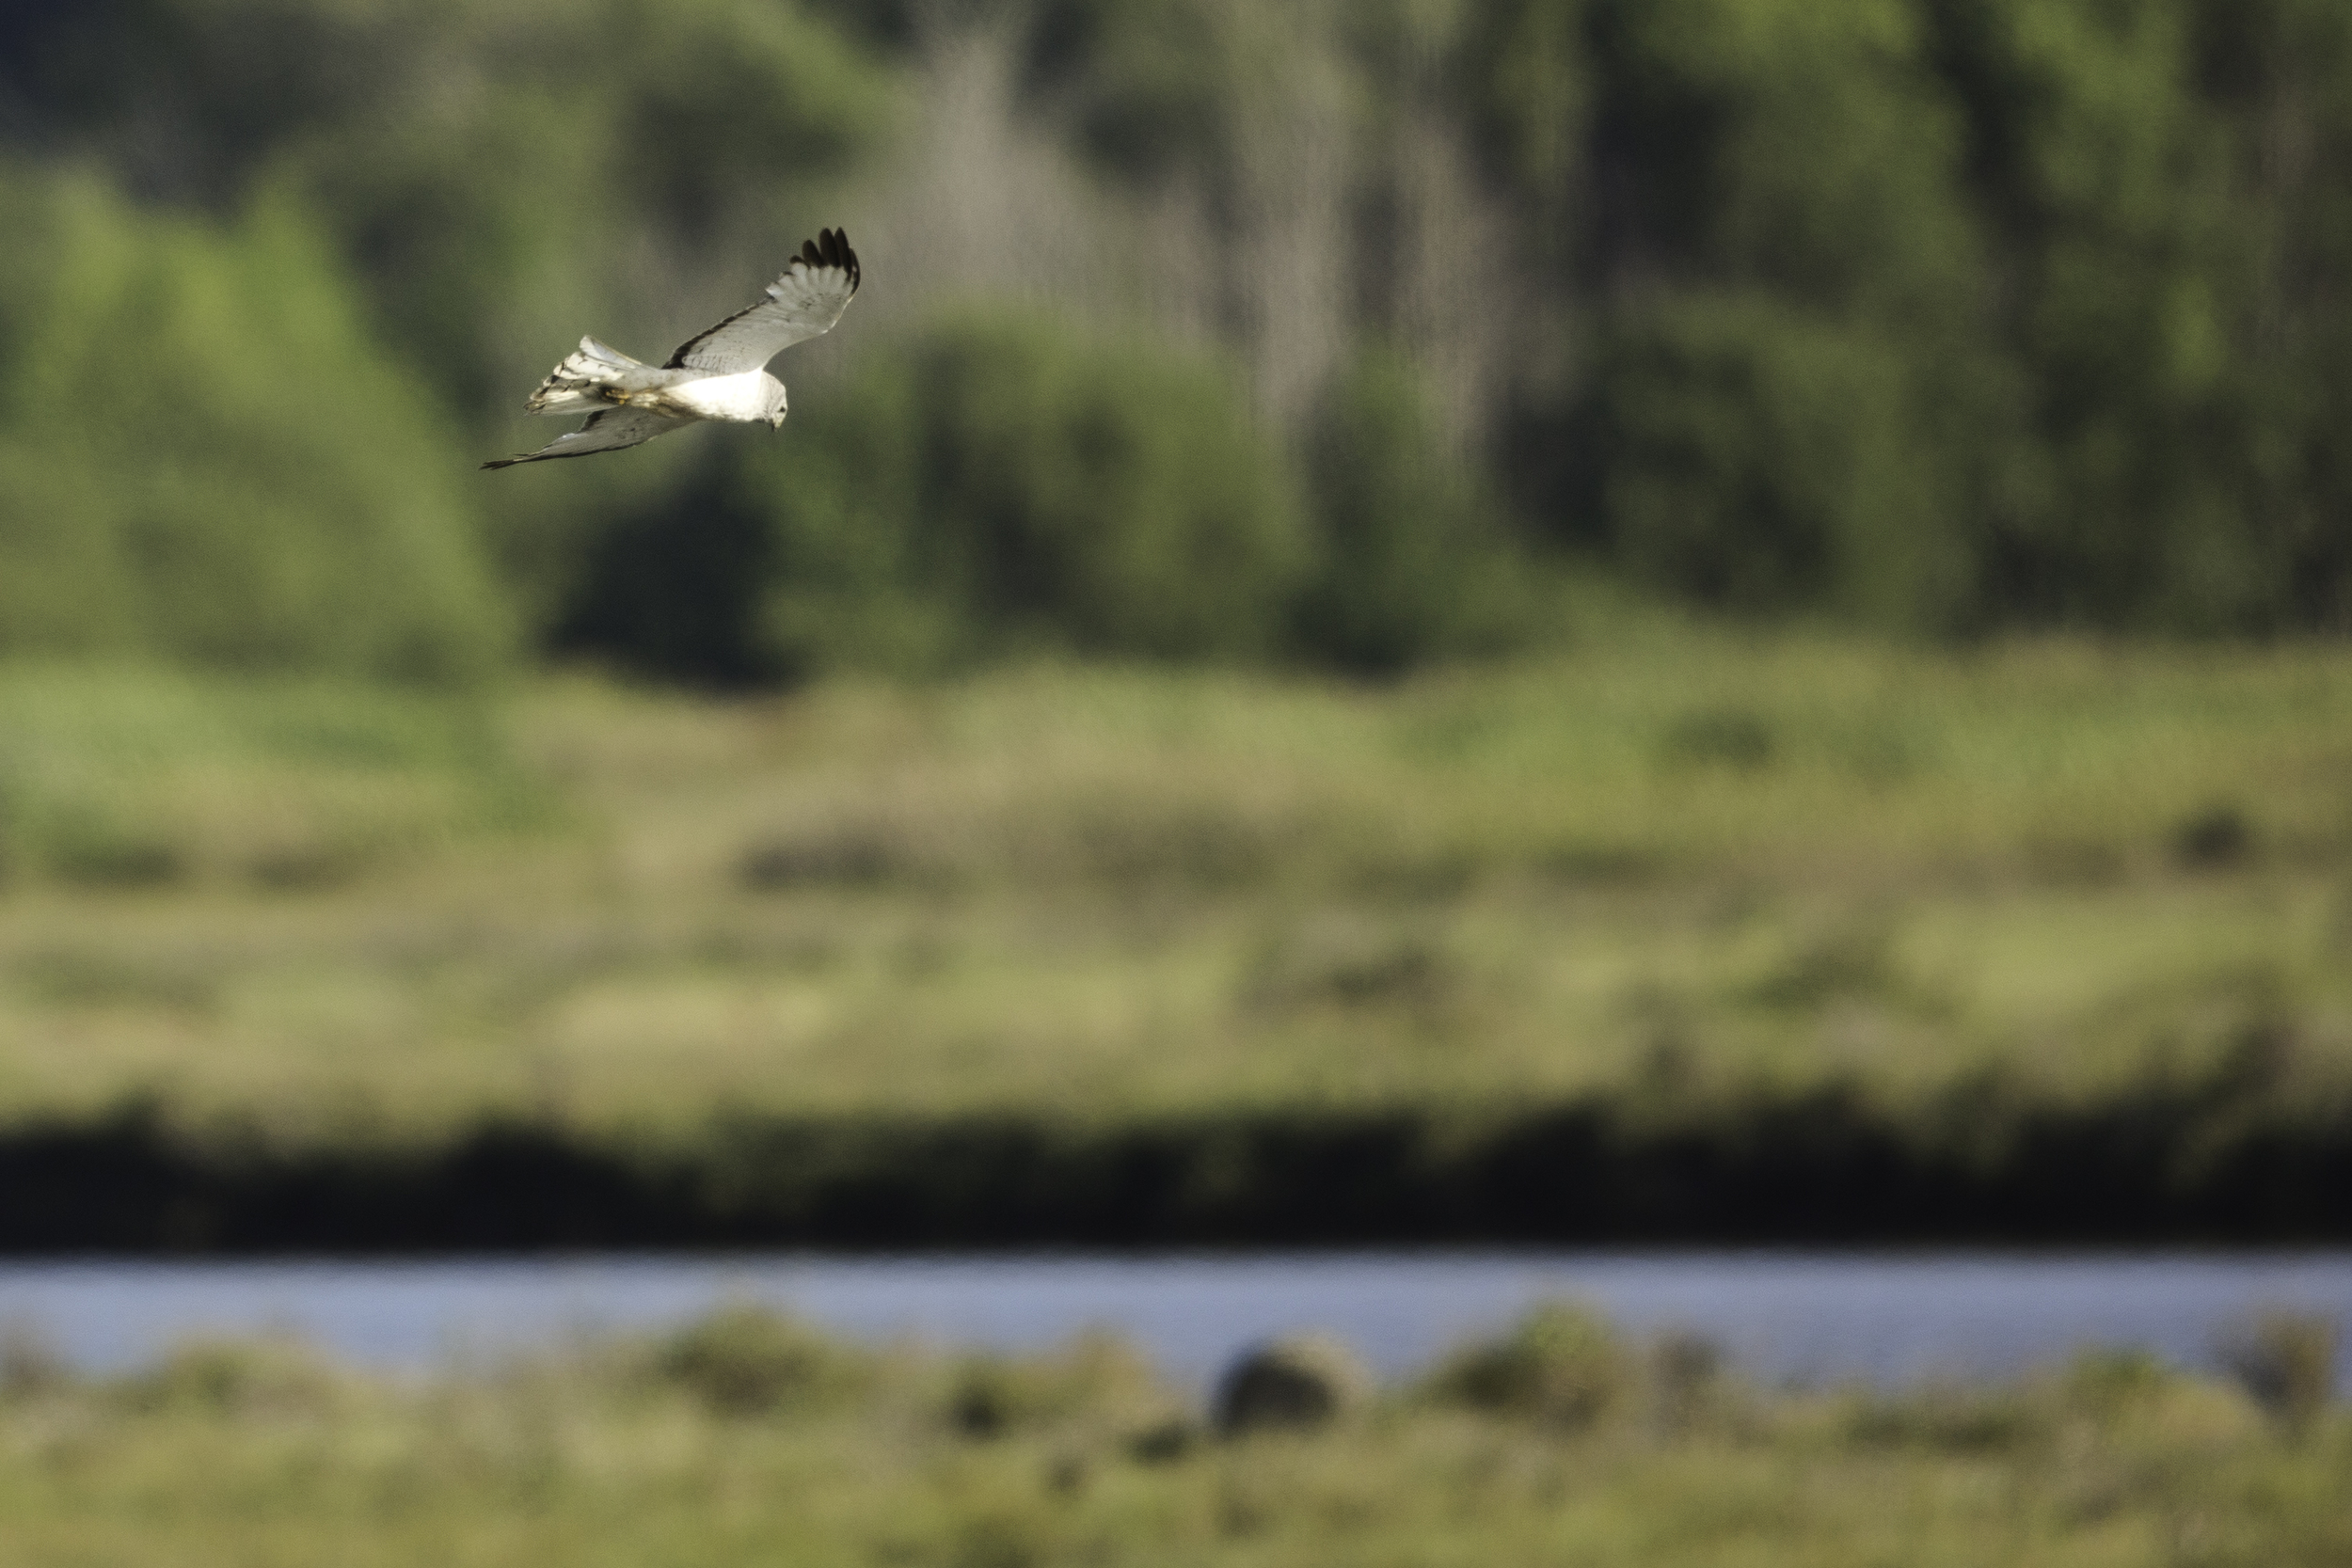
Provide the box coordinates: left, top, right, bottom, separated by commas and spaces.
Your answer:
0, 1309, 2352, 1568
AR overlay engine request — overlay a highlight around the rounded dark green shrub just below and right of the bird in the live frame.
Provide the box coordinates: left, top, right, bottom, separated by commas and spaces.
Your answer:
569, 312, 1308, 684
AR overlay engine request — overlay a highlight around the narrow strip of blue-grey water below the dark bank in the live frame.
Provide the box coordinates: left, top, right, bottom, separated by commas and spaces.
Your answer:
0, 1251, 2352, 1385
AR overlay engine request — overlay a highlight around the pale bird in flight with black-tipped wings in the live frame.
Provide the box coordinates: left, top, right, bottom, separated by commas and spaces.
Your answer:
483, 228, 859, 467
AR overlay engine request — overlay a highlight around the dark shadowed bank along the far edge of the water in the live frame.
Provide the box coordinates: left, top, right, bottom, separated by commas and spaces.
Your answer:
0, 1060, 2352, 1253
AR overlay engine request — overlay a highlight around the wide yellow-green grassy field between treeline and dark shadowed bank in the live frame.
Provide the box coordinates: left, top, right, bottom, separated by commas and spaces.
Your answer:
0, 621, 2352, 1138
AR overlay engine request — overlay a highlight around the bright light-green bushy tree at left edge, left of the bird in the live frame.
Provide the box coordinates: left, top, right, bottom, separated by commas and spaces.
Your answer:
0, 174, 508, 682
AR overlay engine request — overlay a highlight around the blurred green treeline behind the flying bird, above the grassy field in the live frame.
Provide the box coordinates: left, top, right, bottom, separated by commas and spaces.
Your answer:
0, 0, 2352, 682
